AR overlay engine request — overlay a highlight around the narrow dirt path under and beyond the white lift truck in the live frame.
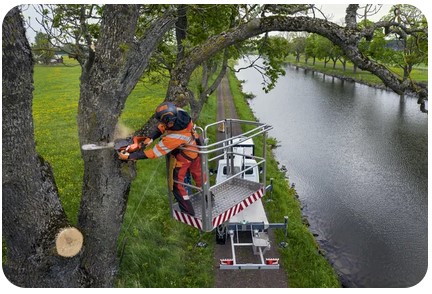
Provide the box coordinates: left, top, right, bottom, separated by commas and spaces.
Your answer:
215, 77, 288, 288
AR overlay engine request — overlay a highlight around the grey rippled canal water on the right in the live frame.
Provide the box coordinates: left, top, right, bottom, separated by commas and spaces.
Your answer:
237, 60, 428, 287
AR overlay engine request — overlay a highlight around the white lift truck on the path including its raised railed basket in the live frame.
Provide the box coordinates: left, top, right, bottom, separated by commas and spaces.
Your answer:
167, 119, 288, 269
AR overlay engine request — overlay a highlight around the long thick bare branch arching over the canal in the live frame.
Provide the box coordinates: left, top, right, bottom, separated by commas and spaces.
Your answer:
171, 14, 428, 113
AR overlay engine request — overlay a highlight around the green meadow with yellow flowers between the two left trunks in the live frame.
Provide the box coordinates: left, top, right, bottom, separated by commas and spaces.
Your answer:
33, 66, 84, 223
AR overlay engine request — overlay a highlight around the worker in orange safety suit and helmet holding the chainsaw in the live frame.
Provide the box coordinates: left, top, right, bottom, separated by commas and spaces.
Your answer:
119, 102, 202, 216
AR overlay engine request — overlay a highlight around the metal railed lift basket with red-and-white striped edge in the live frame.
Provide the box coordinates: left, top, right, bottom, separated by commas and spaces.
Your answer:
167, 119, 272, 232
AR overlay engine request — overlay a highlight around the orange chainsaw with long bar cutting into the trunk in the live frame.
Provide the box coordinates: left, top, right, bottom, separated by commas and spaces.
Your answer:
81, 136, 153, 153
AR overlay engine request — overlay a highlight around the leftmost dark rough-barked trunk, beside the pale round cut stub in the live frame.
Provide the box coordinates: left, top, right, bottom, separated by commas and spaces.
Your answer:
2, 7, 79, 287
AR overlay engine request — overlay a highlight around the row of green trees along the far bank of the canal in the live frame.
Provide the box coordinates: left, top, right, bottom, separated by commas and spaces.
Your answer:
262, 5, 428, 81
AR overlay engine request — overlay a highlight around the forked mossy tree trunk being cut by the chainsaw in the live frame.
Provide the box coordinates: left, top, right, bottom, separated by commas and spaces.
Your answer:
78, 5, 175, 287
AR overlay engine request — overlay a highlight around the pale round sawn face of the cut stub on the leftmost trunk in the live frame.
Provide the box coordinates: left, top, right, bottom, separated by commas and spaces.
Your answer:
56, 227, 83, 257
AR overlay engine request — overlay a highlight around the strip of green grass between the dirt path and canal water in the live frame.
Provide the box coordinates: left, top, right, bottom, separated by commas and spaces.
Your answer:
229, 73, 340, 288
